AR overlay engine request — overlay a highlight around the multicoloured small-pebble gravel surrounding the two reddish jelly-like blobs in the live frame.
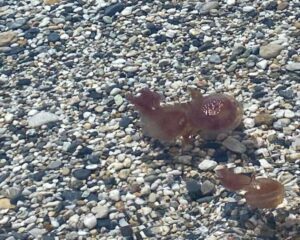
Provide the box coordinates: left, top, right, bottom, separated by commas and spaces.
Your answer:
0, 0, 300, 240
